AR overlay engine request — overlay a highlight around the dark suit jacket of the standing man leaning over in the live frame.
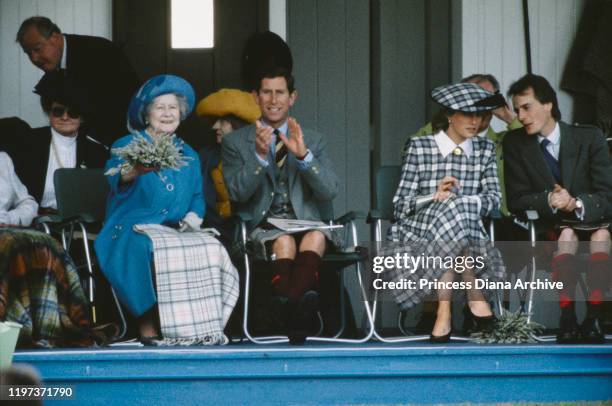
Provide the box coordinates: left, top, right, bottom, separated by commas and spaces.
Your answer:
37, 34, 141, 146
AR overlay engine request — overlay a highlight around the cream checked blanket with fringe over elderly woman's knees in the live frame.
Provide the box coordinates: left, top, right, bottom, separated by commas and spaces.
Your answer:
134, 224, 240, 345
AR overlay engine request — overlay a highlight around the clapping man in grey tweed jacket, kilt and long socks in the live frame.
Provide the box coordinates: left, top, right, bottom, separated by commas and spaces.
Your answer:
222, 68, 338, 342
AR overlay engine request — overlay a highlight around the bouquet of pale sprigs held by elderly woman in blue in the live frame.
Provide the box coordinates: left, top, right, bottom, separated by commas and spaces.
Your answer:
104, 134, 192, 180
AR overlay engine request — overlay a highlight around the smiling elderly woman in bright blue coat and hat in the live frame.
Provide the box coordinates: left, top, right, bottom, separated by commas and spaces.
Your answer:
95, 75, 238, 340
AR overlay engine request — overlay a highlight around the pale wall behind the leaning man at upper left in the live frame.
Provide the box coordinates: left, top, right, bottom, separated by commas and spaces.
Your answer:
0, 0, 112, 127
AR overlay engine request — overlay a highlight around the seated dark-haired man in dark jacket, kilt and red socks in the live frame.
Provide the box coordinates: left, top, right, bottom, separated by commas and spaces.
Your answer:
504, 74, 612, 343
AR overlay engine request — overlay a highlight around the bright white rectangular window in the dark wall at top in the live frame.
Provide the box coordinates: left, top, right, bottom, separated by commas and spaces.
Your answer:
170, 0, 215, 49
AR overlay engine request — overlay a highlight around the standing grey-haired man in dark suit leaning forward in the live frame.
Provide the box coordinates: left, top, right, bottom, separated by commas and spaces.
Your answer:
17, 16, 140, 146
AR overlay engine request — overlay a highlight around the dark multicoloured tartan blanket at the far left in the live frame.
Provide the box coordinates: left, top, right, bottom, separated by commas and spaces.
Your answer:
0, 228, 94, 348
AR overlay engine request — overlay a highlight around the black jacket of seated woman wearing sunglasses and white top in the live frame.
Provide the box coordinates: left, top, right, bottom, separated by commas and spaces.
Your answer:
11, 127, 109, 203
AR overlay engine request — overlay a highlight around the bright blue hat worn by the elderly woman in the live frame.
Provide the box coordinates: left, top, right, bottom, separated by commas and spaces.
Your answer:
128, 75, 195, 131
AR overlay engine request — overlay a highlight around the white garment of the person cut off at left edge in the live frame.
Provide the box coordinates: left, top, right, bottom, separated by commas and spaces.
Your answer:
0, 152, 38, 226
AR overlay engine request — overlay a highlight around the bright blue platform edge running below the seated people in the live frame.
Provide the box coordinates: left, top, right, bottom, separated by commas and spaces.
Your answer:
14, 344, 612, 406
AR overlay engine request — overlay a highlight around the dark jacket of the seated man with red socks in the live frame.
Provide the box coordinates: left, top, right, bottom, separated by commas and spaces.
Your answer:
504, 122, 612, 223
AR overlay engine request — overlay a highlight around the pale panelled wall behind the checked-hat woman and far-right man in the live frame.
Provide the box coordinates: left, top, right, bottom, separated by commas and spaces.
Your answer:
458, 0, 585, 129
